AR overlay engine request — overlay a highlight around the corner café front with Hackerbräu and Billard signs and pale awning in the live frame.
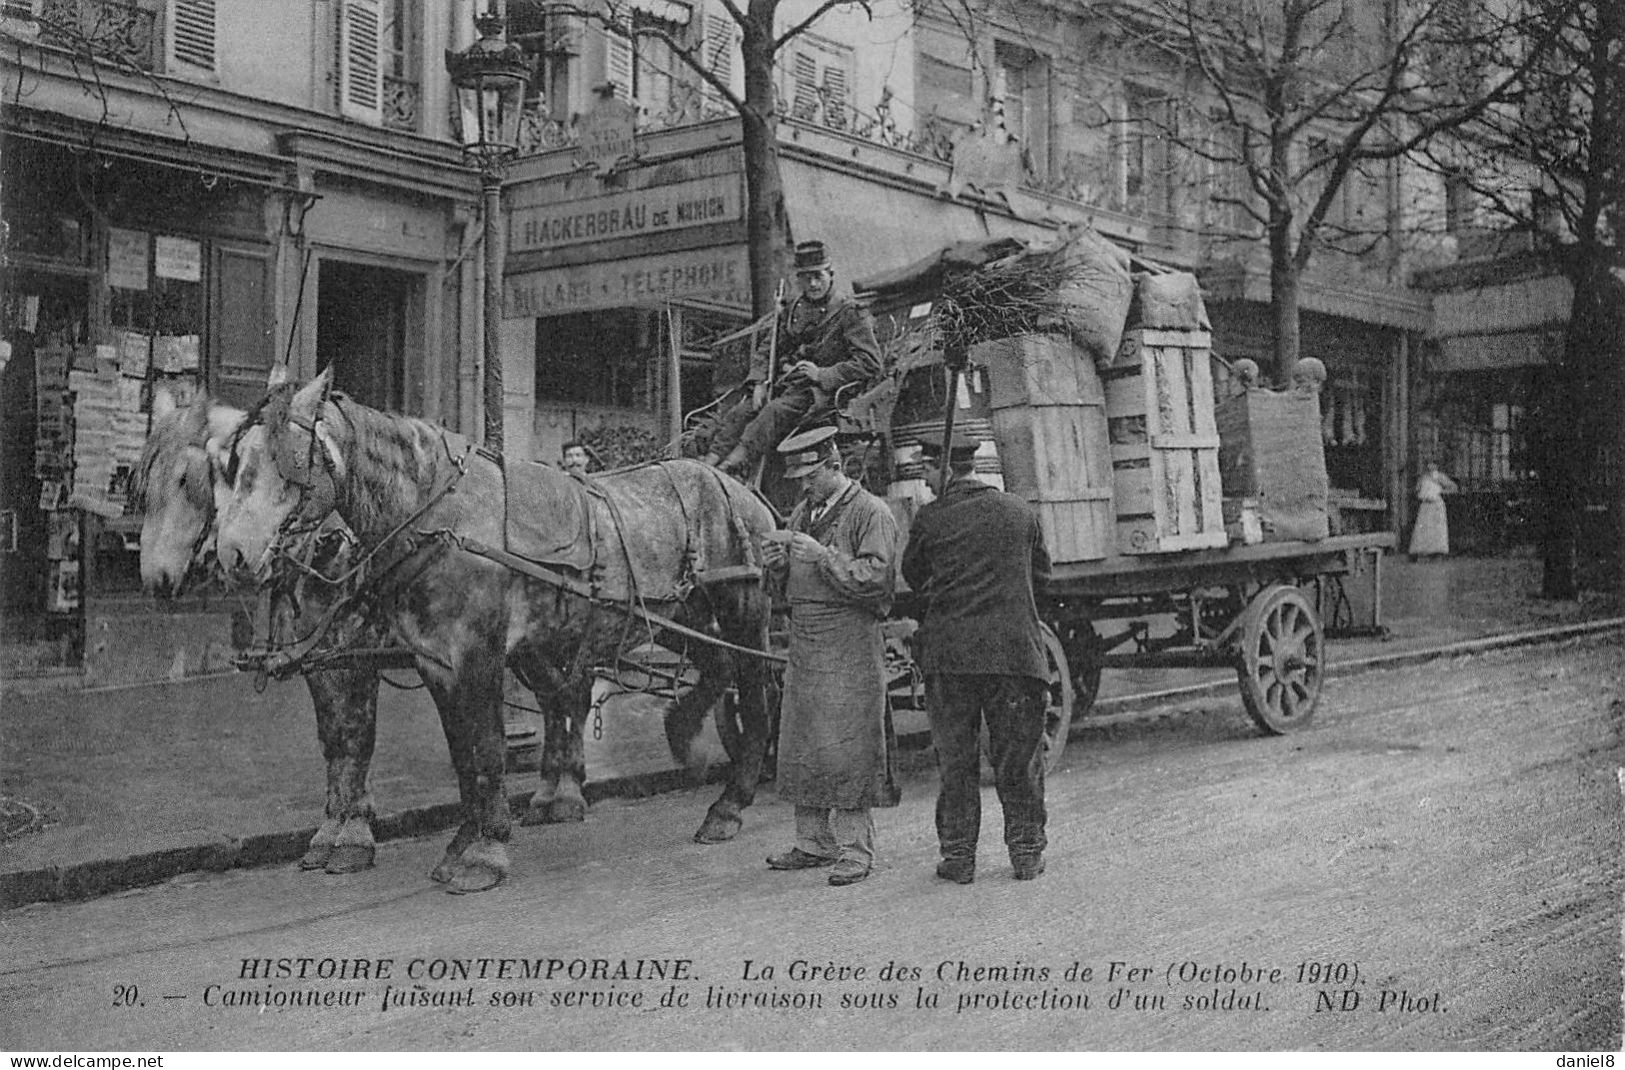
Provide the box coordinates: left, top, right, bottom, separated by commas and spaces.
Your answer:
504, 122, 1144, 465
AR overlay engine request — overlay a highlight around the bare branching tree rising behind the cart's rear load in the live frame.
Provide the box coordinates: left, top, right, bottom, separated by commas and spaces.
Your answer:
1112, 0, 1553, 381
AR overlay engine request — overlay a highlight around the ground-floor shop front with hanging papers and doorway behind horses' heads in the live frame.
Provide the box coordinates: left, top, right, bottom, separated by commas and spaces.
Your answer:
0, 129, 465, 685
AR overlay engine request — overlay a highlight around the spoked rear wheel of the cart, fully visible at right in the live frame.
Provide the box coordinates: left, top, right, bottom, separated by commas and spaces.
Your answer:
1237, 584, 1326, 735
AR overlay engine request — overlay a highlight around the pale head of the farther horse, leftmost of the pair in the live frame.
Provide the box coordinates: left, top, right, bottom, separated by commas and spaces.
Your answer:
133, 390, 245, 597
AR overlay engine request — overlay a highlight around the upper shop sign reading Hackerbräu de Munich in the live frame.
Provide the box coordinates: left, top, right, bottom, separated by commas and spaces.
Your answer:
509, 174, 744, 254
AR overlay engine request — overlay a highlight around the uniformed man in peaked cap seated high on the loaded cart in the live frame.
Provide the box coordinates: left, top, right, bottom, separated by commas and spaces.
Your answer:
705, 241, 881, 473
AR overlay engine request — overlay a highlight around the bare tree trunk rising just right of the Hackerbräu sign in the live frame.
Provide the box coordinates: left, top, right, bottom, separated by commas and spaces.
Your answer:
741, 7, 790, 315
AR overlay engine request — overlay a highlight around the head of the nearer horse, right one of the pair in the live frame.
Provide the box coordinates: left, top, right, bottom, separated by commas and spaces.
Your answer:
218, 372, 345, 582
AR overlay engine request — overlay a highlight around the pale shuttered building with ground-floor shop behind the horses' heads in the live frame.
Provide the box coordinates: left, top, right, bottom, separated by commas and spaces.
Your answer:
0, 0, 479, 683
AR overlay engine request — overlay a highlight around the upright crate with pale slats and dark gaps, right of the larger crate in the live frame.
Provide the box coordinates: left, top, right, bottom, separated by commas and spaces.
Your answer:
1105, 330, 1229, 555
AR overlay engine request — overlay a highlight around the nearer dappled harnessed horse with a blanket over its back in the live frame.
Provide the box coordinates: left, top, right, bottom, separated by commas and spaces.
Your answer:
218, 372, 777, 891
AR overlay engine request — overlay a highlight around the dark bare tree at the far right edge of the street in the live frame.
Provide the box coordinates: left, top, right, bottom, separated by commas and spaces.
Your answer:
1419, 0, 1625, 598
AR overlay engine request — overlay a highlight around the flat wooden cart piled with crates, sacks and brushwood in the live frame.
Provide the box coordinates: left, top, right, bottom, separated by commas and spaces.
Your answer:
705, 230, 1393, 766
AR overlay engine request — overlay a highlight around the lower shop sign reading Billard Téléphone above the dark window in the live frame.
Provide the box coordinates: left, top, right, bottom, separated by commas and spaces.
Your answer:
502, 246, 751, 319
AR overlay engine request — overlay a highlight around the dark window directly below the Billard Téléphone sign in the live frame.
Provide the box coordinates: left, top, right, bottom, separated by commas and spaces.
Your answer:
536, 309, 660, 410
